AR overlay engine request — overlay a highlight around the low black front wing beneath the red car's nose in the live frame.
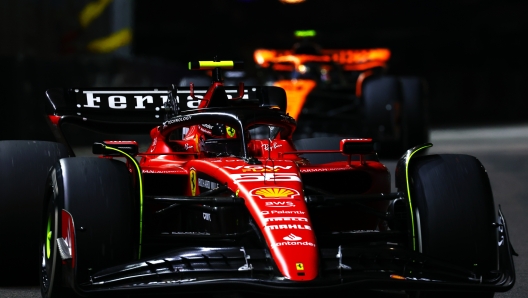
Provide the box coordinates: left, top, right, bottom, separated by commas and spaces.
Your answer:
70, 208, 515, 295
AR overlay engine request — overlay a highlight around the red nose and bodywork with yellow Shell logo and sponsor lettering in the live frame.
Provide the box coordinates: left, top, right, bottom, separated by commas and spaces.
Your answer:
134, 79, 390, 281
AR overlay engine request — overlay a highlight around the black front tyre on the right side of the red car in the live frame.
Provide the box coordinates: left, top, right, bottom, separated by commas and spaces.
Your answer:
409, 154, 498, 297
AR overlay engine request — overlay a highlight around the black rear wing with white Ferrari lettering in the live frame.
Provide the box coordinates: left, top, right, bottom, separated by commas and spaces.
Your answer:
46, 86, 286, 133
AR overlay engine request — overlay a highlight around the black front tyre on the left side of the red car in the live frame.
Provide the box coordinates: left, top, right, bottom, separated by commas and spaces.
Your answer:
46, 157, 136, 287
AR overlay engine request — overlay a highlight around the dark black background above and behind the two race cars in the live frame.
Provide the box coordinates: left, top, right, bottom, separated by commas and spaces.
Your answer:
0, 0, 528, 140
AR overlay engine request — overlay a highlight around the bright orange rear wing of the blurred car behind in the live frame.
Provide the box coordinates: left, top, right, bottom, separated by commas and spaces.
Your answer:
253, 48, 391, 71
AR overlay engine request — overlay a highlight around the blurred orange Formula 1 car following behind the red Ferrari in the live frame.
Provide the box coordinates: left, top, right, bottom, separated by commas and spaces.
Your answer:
254, 31, 429, 157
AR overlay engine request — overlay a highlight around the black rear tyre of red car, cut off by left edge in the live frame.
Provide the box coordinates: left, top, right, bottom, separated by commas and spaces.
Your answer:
0, 141, 68, 285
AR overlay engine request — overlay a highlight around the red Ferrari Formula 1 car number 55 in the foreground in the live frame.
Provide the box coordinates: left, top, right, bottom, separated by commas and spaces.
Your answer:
0, 61, 515, 297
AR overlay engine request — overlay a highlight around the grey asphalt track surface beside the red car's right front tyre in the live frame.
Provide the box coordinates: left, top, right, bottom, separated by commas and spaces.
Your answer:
0, 124, 528, 298
